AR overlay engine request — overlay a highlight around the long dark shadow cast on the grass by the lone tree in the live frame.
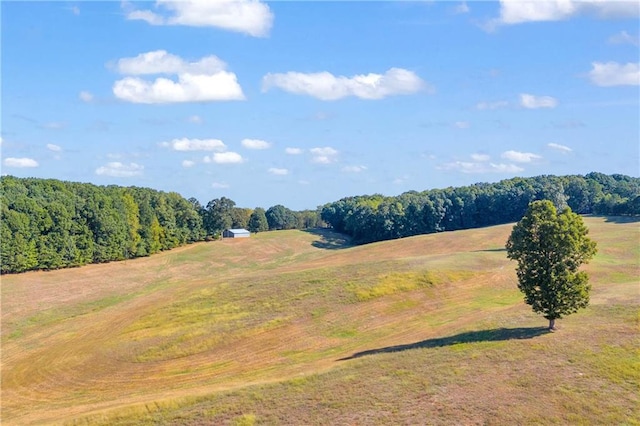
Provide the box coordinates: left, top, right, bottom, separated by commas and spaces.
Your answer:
337, 327, 550, 361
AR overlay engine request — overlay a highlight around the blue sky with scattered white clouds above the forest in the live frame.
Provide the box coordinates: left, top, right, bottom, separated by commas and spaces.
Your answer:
1, 0, 640, 210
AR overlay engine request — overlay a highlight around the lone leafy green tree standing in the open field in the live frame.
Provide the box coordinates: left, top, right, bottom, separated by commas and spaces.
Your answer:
506, 200, 596, 330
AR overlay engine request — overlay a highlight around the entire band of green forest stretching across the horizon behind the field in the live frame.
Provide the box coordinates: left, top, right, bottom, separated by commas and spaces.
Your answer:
0, 173, 640, 274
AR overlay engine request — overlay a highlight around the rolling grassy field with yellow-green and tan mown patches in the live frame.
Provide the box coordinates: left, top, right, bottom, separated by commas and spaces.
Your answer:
1, 217, 640, 425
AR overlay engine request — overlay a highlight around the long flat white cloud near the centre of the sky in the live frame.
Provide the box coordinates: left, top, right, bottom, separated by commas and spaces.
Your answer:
262, 68, 428, 101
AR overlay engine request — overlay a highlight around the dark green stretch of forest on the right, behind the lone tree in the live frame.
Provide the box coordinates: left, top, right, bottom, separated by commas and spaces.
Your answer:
321, 173, 640, 243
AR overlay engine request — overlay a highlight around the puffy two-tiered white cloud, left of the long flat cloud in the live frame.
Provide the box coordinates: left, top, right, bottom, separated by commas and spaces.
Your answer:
113, 50, 245, 104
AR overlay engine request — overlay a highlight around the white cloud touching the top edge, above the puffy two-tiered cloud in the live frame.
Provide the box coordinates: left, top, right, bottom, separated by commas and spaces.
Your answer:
123, 0, 273, 37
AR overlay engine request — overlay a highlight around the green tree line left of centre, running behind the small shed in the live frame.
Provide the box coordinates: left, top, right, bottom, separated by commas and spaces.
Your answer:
0, 176, 321, 274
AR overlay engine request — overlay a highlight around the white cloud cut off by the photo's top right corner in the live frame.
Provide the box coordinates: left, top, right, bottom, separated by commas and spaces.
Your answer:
492, 0, 640, 26
